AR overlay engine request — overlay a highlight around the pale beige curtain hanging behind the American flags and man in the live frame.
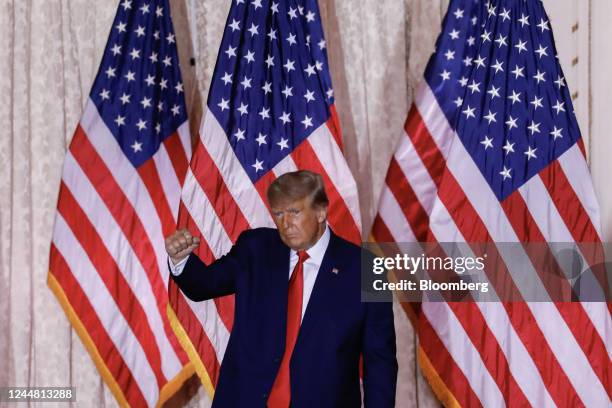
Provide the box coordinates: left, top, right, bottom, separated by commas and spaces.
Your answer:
0, 0, 610, 407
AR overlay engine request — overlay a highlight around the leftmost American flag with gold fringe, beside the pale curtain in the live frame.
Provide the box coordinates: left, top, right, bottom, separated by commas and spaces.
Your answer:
48, 0, 193, 406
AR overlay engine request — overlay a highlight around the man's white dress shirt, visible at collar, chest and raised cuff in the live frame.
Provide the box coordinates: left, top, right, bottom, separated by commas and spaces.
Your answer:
168, 224, 331, 319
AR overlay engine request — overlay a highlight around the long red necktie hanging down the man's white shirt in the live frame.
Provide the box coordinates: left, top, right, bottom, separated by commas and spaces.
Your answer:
268, 251, 308, 408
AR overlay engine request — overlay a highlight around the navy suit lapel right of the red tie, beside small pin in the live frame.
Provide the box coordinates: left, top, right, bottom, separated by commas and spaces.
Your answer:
295, 231, 338, 349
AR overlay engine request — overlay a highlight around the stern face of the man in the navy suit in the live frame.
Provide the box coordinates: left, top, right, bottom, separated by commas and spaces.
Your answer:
271, 197, 327, 251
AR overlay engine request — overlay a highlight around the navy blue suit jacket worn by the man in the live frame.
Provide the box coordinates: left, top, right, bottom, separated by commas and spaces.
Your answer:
171, 228, 397, 408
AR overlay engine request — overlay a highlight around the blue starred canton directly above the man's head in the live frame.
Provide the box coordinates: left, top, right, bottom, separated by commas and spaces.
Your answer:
208, 0, 333, 182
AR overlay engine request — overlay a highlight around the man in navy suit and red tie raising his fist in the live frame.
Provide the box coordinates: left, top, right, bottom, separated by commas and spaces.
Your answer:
166, 171, 397, 408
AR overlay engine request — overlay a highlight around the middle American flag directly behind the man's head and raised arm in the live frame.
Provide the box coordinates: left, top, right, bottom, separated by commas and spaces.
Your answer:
168, 0, 361, 394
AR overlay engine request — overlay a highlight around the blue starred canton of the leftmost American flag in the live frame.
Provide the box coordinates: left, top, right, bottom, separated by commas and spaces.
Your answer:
90, 0, 187, 167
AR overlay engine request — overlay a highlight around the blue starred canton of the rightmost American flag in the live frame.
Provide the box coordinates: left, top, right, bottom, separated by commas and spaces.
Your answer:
425, 0, 581, 200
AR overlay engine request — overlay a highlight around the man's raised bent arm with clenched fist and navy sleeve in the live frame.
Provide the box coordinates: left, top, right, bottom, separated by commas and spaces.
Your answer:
166, 230, 247, 302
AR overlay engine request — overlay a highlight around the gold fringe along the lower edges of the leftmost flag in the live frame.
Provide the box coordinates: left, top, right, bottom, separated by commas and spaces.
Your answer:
47, 271, 195, 407
